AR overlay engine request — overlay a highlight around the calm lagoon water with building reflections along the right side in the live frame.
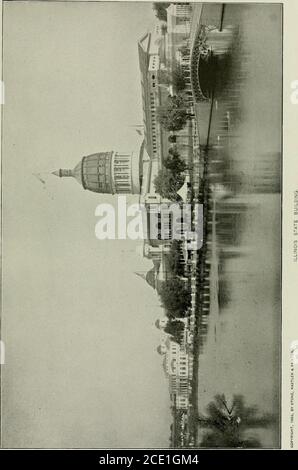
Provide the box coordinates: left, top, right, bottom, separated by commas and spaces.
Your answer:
197, 4, 282, 447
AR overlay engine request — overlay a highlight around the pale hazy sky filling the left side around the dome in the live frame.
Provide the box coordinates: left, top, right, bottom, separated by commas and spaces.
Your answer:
2, 2, 170, 447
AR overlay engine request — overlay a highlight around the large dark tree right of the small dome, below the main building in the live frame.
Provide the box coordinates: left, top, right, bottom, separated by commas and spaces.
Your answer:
160, 278, 191, 318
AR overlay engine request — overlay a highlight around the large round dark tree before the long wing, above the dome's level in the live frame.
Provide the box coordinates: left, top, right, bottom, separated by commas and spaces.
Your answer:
157, 95, 191, 131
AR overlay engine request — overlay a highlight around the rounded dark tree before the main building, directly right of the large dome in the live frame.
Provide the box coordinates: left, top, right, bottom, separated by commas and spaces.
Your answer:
153, 168, 185, 201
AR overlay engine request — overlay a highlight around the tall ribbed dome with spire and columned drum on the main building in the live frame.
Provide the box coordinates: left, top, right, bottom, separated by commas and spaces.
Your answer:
53, 148, 142, 194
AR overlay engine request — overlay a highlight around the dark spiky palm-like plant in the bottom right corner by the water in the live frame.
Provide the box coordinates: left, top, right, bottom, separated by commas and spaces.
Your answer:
198, 395, 274, 448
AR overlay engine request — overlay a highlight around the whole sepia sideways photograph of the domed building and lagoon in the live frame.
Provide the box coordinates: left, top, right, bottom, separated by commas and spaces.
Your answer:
1, 0, 282, 449
